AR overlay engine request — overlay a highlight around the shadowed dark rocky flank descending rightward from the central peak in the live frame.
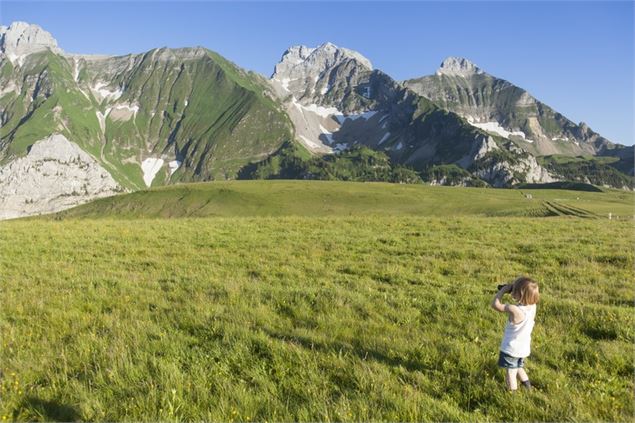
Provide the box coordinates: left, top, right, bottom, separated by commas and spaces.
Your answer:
310, 67, 556, 186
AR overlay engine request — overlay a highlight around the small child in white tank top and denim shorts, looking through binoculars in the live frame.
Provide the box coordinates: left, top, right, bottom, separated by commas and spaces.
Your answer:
492, 276, 540, 391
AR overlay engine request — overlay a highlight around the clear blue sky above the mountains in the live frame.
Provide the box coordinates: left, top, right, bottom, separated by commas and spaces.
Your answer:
0, 0, 635, 145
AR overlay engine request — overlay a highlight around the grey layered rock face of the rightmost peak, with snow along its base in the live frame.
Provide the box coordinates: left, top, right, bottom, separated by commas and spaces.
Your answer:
404, 57, 613, 155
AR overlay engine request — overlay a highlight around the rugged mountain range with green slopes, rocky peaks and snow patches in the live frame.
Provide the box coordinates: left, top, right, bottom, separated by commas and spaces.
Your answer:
0, 22, 633, 218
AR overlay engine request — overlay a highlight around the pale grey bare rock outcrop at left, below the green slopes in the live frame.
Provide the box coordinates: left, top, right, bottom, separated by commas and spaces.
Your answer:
0, 134, 123, 219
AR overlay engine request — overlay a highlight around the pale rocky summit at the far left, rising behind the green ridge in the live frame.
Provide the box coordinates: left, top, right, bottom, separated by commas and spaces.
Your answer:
0, 22, 62, 61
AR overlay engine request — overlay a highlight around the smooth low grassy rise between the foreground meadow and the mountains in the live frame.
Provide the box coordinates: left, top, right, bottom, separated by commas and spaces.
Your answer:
57, 181, 635, 219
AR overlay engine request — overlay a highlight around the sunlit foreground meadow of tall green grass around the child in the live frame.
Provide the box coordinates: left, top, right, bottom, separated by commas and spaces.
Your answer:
0, 181, 635, 421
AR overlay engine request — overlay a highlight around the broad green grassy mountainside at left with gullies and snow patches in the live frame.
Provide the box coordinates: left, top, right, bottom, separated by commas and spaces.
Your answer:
0, 48, 292, 189
